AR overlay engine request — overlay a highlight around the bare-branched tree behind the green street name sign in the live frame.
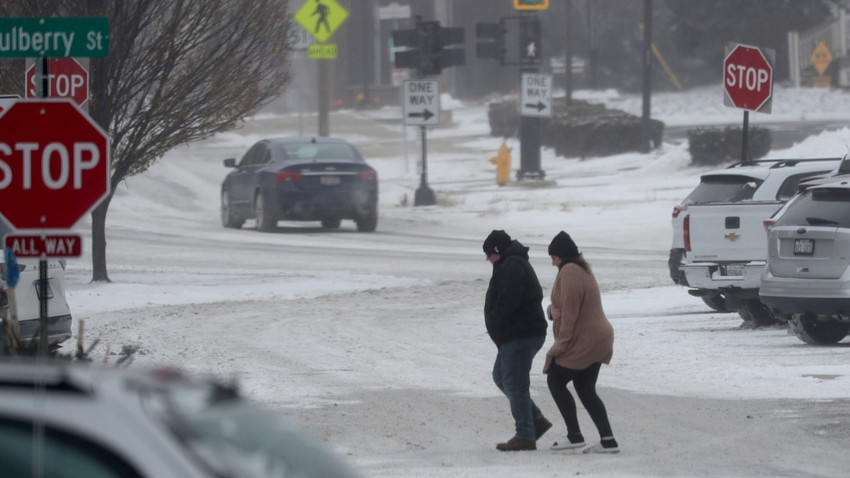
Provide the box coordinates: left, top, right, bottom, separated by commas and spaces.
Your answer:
0, 0, 292, 280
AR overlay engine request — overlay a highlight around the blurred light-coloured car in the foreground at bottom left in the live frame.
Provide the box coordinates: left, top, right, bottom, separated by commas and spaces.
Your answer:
0, 360, 359, 478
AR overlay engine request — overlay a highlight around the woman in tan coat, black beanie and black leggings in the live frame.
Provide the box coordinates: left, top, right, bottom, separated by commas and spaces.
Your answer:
543, 231, 620, 453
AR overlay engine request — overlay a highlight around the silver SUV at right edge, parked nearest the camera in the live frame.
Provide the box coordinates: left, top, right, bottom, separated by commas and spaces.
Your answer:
759, 180, 850, 344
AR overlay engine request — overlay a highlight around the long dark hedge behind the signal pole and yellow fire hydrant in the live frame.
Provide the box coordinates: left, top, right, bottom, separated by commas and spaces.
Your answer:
488, 98, 664, 158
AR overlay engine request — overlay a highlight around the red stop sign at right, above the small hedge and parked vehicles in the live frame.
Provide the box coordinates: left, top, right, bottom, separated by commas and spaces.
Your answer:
723, 45, 773, 111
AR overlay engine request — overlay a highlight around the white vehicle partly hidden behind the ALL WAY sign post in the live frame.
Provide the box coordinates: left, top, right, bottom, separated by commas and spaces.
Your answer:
0, 254, 71, 351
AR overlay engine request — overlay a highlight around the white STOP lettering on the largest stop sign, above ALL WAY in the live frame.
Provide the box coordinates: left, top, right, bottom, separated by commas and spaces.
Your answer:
0, 142, 100, 191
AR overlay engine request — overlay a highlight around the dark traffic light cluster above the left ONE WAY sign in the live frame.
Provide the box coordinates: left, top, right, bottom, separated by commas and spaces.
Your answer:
393, 20, 466, 76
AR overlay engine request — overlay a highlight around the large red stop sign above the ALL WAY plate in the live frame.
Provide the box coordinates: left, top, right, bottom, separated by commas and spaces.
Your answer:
0, 99, 110, 229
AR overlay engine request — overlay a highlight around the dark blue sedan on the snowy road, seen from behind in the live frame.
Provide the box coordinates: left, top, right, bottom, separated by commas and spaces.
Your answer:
221, 137, 378, 232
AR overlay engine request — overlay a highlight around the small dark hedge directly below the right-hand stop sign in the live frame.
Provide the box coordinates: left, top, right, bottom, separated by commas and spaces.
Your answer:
688, 127, 771, 166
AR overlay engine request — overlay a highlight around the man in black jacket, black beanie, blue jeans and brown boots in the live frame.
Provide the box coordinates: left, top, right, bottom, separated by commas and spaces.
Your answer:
484, 230, 552, 451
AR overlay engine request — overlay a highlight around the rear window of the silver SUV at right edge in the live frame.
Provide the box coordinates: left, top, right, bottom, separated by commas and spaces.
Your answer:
776, 188, 850, 228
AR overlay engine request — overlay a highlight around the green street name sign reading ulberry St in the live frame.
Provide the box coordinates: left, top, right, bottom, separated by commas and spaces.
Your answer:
0, 17, 109, 58
